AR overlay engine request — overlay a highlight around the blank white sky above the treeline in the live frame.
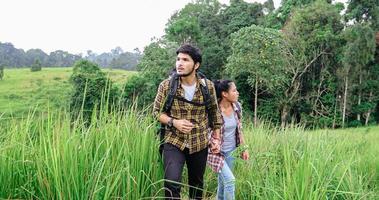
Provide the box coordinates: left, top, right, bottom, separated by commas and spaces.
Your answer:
0, 0, 280, 55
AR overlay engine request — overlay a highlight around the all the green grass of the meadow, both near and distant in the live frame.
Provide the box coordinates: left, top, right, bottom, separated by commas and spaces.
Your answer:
0, 68, 379, 200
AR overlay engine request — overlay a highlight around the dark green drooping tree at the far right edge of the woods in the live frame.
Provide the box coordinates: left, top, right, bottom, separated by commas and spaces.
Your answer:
342, 23, 378, 124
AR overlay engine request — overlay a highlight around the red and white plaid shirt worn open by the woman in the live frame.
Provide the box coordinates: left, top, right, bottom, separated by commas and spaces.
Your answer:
207, 102, 243, 173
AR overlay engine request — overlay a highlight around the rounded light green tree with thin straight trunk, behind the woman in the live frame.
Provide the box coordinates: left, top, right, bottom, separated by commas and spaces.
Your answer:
226, 25, 284, 125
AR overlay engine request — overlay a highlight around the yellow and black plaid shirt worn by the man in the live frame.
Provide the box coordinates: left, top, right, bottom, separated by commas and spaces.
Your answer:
153, 74, 222, 154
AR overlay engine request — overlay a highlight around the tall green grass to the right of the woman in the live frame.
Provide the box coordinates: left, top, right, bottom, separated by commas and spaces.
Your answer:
236, 124, 379, 200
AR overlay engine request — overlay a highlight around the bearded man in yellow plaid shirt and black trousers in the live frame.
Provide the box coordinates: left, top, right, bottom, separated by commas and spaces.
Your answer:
154, 44, 222, 199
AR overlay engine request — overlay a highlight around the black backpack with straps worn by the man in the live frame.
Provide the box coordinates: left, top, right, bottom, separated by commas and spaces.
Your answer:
159, 72, 213, 155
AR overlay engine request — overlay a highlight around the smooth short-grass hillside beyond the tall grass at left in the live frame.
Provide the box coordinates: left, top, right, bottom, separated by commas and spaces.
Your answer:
0, 68, 135, 117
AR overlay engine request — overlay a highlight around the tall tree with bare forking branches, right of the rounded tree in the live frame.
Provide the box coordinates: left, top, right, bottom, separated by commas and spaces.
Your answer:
281, 1, 343, 126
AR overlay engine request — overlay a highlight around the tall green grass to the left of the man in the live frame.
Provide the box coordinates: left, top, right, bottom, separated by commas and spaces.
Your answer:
0, 106, 163, 199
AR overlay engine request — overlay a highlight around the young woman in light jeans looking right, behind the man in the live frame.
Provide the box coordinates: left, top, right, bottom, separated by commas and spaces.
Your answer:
208, 80, 249, 200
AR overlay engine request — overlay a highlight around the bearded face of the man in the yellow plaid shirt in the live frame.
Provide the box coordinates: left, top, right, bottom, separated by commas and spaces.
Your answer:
176, 53, 200, 76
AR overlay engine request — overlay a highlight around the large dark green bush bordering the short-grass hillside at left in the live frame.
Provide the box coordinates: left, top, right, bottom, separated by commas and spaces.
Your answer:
70, 60, 118, 123
